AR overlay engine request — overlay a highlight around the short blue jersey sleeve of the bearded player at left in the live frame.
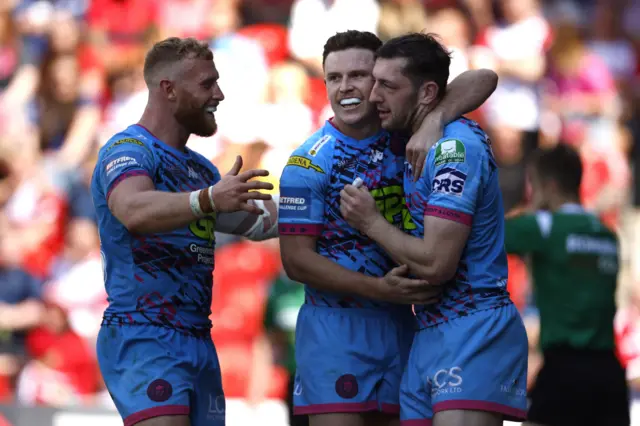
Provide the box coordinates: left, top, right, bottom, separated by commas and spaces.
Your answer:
96, 137, 155, 200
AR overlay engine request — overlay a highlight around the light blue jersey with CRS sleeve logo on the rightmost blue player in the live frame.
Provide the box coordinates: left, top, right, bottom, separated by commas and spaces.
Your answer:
404, 118, 511, 327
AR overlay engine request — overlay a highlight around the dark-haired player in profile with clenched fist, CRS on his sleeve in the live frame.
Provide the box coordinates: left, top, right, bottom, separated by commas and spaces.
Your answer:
341, 34, 528, 426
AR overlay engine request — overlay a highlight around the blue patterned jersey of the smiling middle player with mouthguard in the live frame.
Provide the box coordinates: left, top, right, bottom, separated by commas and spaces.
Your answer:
279, 121, 415, 309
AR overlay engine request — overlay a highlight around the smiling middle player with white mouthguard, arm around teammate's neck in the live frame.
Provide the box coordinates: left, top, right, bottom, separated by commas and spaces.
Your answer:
279, 31, 497, 426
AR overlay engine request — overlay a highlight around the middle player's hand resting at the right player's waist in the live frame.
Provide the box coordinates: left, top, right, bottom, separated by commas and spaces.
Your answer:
379, 265, 442, 305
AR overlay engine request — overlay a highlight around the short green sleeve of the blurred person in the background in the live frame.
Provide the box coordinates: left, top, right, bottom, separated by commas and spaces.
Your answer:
504, 212, 552, 256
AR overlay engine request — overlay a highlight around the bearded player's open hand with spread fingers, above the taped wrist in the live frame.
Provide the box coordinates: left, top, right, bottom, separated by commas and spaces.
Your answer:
211, 155, 273, 214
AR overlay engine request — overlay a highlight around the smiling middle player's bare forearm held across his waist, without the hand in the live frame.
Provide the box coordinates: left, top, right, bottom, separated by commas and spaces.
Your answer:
283, 250, 380, 299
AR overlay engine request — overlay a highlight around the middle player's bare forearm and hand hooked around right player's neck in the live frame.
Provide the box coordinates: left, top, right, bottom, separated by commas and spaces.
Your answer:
406, 69, 498, 180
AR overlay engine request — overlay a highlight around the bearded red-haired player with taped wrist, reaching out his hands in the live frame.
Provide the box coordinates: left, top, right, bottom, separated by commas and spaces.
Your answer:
91, 38, 277, 426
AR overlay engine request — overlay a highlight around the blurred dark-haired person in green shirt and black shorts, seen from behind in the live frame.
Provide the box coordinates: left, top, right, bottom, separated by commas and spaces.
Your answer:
505, 145, 630, 426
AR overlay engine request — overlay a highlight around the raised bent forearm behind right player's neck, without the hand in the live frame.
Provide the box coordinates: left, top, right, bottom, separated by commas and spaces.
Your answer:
432, 69, 498, 124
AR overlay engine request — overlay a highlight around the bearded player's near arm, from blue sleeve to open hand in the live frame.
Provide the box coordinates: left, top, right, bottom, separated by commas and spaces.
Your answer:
100, 137, 271, 234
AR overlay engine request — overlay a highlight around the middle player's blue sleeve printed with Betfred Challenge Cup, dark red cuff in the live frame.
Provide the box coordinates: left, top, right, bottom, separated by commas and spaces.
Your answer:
278, 144, 331, 236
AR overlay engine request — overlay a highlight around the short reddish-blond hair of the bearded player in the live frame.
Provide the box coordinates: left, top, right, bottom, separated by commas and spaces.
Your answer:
143, 37, 213, 86
